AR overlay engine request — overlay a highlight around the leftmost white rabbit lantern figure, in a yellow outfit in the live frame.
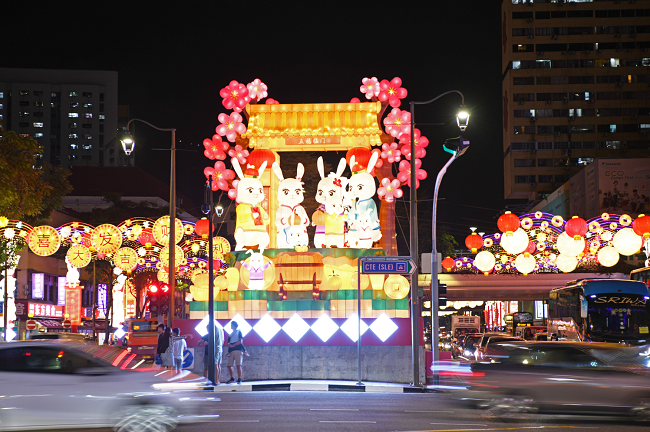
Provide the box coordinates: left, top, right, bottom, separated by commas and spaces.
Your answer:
232, 158, 270, 250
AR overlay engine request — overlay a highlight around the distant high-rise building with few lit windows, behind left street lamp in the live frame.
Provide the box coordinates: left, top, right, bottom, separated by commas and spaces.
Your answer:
0, 68, 133, 168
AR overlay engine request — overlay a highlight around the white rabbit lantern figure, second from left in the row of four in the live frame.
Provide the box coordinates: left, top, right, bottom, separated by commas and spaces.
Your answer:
272, 162, 309, 249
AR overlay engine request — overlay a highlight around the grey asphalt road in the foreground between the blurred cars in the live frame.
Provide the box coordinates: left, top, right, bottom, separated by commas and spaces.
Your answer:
177, 392, 650, 432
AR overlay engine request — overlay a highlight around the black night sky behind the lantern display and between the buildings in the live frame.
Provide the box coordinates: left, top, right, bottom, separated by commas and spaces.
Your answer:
5, 0, 505, 248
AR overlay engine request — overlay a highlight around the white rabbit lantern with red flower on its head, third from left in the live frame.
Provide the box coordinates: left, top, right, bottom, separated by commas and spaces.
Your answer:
312, 156, 348, 248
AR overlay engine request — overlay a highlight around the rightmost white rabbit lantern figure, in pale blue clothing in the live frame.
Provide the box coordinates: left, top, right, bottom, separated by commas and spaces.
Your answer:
348, 152, 381, 247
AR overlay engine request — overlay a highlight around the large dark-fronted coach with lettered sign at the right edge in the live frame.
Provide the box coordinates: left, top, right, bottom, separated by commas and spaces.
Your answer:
547, 279, 650, 345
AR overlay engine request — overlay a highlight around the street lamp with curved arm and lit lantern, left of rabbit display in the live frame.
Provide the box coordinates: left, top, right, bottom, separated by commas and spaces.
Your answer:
120, 119, 176, 327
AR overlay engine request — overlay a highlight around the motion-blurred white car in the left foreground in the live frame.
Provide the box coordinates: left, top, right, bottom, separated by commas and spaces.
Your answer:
0, 340, 219, 432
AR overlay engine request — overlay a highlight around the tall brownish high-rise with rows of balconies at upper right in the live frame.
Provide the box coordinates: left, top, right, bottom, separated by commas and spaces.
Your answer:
501, 0, 650, 200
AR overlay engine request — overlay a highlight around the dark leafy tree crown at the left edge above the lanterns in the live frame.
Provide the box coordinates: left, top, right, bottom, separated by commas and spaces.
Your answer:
0, 130, 72, 225
